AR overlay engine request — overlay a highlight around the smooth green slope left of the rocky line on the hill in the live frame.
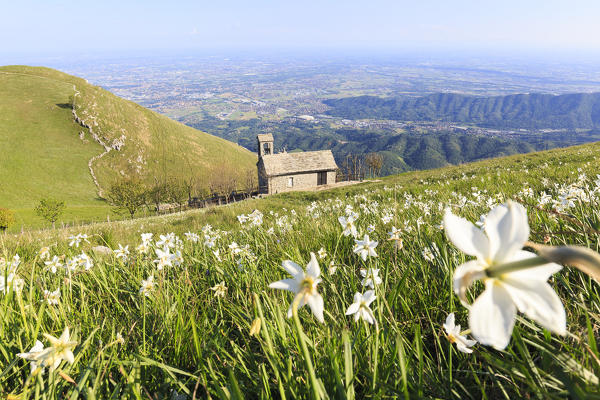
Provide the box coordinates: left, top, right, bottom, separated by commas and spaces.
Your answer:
0, 67, 102, 208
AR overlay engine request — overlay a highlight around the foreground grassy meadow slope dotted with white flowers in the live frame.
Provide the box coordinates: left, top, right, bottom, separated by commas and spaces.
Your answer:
0, 144, 600, 399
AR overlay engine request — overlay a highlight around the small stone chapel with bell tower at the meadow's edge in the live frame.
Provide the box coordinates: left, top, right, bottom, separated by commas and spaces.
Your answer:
256, 133, 338, 194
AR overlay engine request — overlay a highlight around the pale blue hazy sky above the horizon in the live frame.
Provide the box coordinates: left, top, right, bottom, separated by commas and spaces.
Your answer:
0, 0, 600, 56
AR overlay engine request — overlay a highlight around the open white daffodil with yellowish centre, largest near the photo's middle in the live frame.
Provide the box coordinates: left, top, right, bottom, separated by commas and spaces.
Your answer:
269, 253, 325, 322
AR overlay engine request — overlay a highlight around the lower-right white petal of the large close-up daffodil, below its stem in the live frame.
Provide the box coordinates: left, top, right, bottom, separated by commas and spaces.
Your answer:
502, 277, 567, 335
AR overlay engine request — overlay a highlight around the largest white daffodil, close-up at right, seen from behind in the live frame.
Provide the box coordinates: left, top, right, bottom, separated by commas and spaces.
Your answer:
444, 201, 566, 350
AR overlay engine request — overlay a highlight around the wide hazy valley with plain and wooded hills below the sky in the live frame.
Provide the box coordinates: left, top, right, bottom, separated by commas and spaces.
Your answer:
50, 56, 600, 175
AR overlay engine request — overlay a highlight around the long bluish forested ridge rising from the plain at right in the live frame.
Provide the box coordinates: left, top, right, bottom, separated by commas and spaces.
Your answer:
323, 93, 600, 129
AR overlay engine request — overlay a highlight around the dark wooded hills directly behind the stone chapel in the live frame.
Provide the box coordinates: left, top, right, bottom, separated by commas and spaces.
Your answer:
190, 118, 579, 175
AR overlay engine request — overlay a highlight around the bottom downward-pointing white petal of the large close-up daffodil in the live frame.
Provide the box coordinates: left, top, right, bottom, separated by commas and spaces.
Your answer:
469, 280, 516, 350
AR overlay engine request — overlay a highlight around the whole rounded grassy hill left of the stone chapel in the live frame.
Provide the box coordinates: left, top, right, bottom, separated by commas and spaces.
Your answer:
0, 66, 255, 228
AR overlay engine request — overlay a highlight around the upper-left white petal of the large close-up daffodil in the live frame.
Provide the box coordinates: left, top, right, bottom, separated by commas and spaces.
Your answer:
444, 210, 489, 259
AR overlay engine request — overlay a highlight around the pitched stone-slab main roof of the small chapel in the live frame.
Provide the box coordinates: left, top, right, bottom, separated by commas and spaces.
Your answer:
262, 150, 338, 176
